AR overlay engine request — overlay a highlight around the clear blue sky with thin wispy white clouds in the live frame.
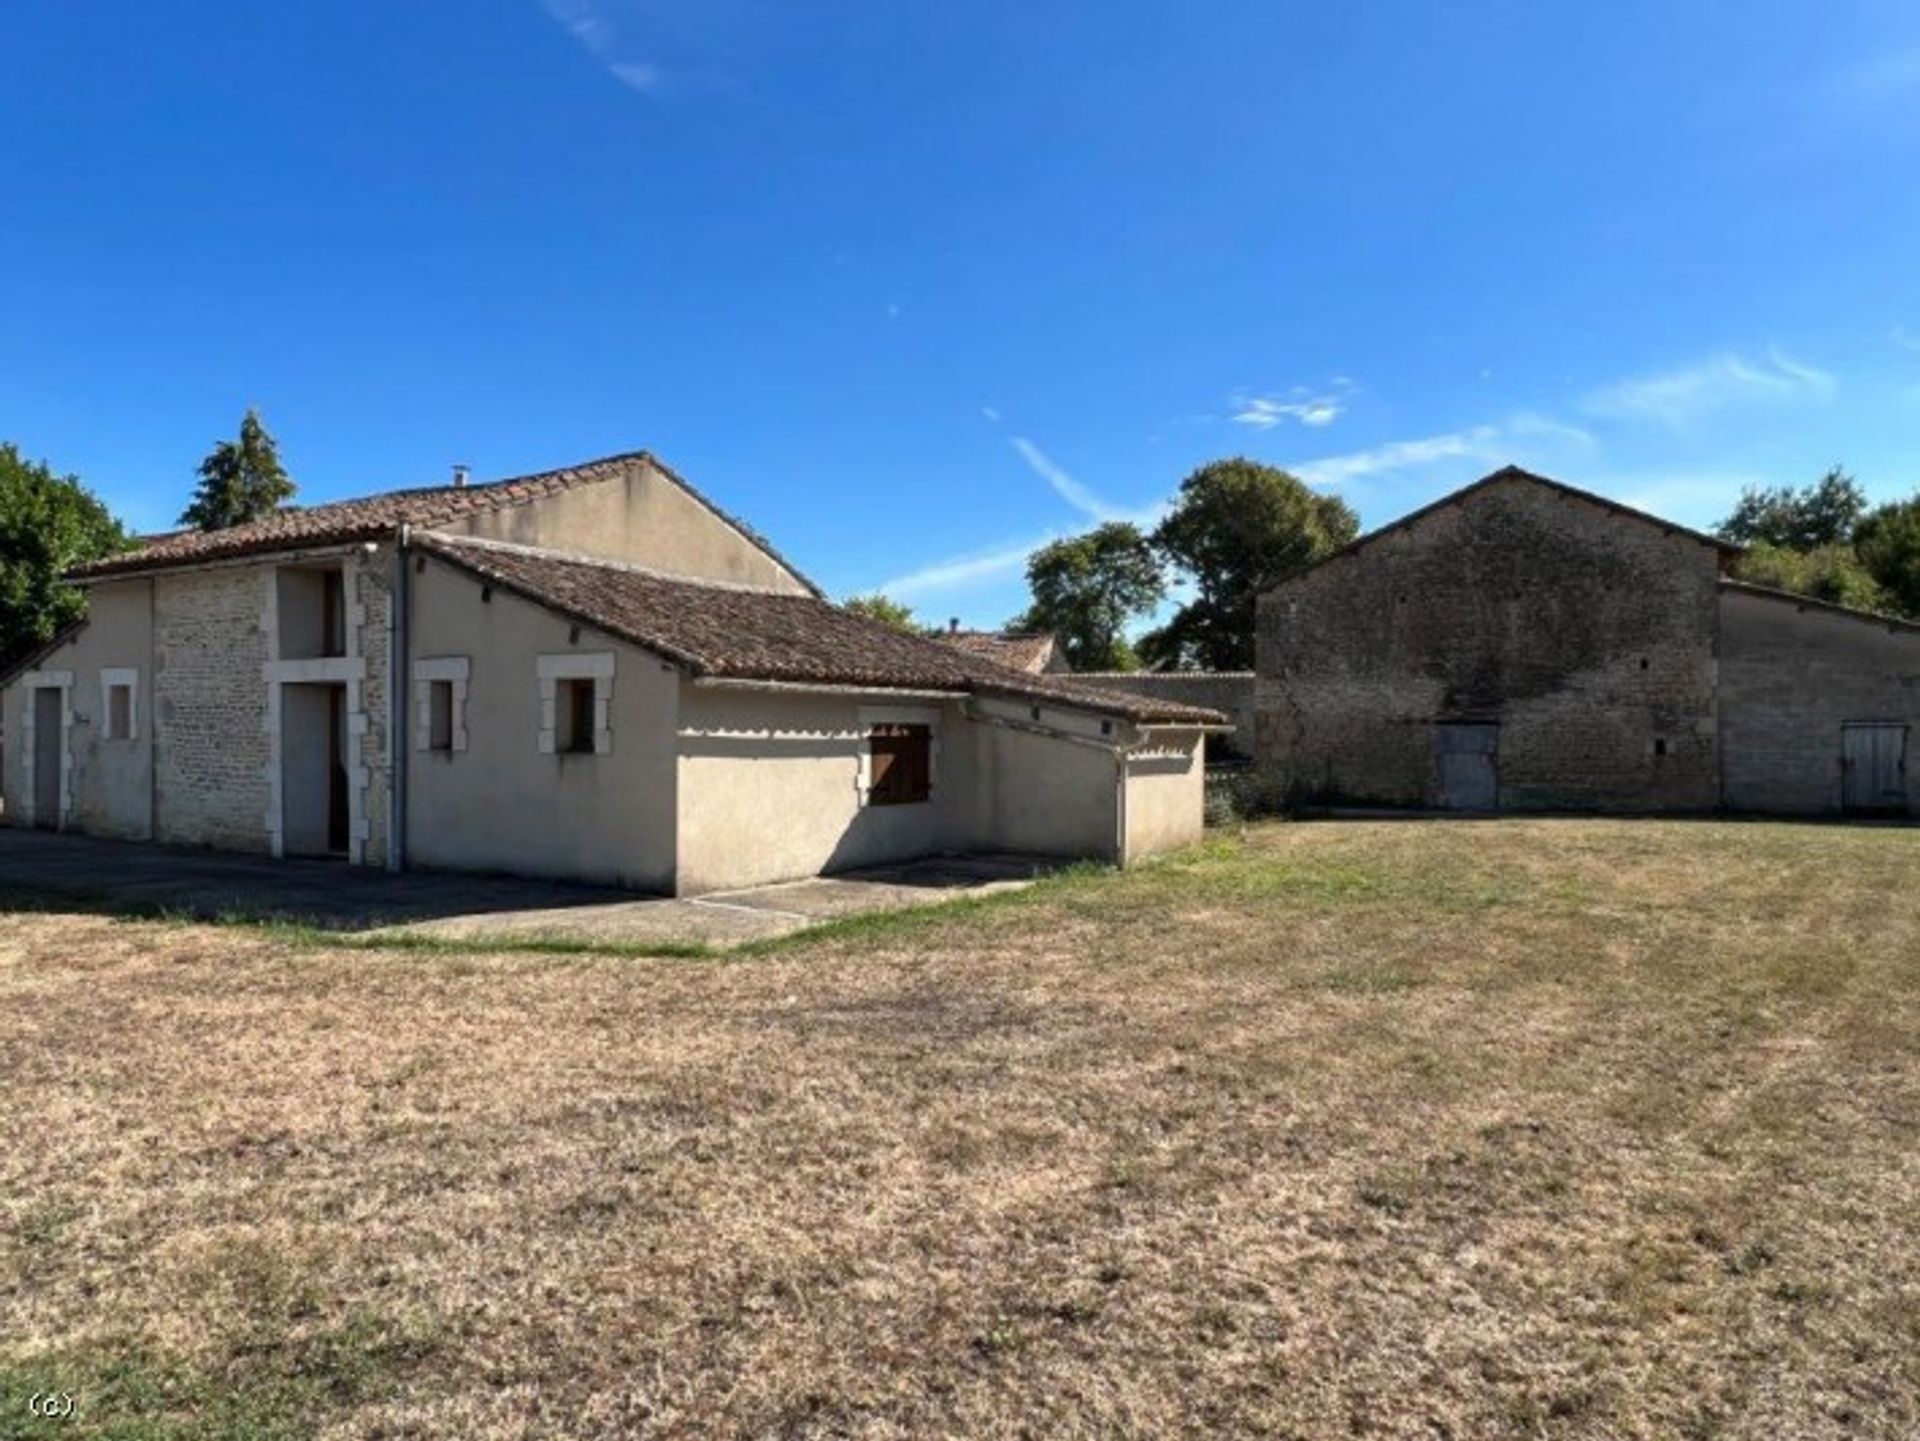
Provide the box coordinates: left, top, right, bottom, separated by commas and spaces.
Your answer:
0, 0, 1920, 624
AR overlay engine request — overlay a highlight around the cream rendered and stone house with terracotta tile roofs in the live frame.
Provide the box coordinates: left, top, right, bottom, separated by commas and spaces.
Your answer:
0, 453, 1223, 894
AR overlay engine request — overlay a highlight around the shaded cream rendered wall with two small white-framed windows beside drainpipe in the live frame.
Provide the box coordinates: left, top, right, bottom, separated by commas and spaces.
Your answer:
403, 558, 680, 890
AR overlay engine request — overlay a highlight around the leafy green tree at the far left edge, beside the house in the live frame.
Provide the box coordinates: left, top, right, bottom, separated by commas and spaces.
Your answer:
0, 443, 129, 670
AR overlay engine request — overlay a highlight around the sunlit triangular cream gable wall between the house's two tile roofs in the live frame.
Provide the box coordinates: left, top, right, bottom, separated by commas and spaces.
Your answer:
444, 466, 806, 595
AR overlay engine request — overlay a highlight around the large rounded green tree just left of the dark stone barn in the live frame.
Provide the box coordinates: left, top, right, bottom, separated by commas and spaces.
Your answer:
1140, 457, 1359, 670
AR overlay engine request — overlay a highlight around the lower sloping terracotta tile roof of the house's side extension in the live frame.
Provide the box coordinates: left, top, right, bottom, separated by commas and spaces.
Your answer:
426, 535, 1225, 725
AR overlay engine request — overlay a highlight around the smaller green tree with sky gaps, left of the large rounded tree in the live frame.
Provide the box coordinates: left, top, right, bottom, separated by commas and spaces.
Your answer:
1008, 520, 1167, 670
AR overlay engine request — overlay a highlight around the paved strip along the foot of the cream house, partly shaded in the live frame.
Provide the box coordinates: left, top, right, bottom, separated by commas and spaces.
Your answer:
0, 825, 1058, 946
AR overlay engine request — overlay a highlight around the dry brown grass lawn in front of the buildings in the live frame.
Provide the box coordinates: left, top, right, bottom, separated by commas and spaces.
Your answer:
0, 821, 1920, 1439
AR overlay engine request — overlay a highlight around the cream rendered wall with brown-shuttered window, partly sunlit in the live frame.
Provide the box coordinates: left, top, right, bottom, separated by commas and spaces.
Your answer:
680, 683, 977, 894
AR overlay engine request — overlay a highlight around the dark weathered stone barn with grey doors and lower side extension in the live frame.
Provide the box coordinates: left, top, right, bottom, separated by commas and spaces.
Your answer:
1254, 466, 1920, 815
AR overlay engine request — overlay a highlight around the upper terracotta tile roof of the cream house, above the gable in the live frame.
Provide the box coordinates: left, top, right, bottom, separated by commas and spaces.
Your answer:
71, 451, 818, 593
